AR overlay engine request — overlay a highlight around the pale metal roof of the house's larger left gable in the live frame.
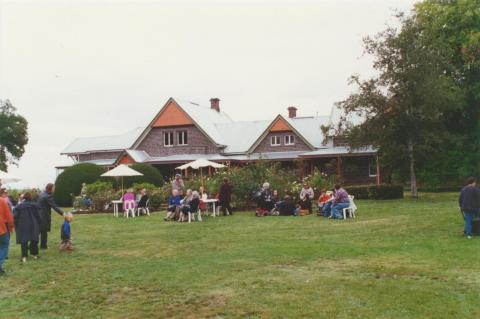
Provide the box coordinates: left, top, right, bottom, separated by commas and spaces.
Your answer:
133, 98, 232, 148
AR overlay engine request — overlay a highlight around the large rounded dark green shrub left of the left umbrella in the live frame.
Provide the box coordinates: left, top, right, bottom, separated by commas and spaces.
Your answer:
53, 163, 105, 207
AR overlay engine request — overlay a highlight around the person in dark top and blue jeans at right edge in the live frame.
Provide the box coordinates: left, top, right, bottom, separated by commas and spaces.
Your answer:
458, 177, 480, 239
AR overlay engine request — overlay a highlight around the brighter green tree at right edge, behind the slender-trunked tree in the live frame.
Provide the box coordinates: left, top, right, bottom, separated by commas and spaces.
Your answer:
414, 0, 480, 184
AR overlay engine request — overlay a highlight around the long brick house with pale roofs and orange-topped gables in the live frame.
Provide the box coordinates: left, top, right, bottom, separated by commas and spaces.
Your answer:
59, 98, 380, 184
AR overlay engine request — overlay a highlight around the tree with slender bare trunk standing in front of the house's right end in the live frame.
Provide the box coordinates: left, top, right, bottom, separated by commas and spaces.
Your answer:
335, 14, 462, 197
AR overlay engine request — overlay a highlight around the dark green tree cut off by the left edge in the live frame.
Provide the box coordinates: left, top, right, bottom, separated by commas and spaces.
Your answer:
0, 100, 28, 171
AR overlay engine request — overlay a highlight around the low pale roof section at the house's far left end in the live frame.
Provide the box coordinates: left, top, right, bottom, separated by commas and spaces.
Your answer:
60, 127, 143, 155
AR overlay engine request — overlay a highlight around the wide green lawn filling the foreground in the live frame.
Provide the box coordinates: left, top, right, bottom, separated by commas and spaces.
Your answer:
0, 194, 480, 318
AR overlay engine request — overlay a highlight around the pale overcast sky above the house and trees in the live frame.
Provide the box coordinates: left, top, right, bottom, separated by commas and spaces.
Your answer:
0, 0, 416, 187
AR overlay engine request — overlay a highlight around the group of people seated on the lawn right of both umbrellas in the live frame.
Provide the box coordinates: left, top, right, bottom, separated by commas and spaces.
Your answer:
253, 182, 351, 219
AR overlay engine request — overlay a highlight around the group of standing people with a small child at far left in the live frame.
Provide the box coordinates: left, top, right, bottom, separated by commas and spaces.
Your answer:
0, 183, 73, 274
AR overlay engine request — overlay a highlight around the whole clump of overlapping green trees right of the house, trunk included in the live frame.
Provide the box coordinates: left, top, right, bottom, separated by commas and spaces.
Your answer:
328, 0, 480, 196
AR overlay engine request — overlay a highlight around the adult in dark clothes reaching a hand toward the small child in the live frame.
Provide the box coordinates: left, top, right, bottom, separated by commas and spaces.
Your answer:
38, 183, 64, 249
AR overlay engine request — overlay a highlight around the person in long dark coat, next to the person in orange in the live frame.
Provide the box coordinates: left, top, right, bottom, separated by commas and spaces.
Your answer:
13, 193, 41, 262
